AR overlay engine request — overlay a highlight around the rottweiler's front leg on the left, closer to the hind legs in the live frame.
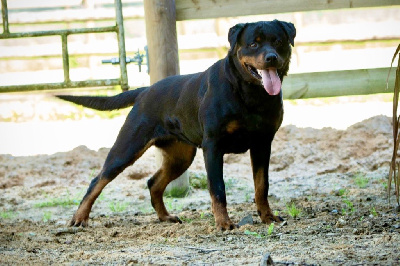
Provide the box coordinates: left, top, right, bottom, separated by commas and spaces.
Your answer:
203, 143, 235, 230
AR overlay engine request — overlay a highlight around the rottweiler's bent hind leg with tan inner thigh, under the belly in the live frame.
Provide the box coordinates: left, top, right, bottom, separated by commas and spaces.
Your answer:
147, 139, 196, 223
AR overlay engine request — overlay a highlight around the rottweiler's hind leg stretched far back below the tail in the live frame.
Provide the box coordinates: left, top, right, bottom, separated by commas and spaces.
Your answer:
70, 112, 154, 227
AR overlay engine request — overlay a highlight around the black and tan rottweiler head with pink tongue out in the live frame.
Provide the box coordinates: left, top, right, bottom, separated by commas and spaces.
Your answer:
228, 20, 296, 95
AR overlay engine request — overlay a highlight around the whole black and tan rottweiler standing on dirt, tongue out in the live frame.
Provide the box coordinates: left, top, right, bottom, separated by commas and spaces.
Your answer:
57, 20, 296, 230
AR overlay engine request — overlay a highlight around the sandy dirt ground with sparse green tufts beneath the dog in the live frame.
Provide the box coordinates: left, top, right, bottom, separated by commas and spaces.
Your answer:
0, 107, 400, 265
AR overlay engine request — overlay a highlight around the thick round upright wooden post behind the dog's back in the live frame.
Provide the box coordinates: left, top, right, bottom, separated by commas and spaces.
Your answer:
143, 0, 189, 195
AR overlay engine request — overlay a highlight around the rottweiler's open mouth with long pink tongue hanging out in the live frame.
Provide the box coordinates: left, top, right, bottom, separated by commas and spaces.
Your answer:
245, 63, 282, 95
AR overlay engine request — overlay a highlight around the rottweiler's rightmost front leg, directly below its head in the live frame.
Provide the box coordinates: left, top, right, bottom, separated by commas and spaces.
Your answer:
250, 140, 283, 224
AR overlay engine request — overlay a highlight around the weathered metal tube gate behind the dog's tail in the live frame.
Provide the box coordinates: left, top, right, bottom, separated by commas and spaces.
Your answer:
0, 0, 129, 92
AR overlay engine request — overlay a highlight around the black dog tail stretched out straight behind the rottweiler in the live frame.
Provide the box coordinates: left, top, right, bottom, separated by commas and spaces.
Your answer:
56, 87, 147, 111
